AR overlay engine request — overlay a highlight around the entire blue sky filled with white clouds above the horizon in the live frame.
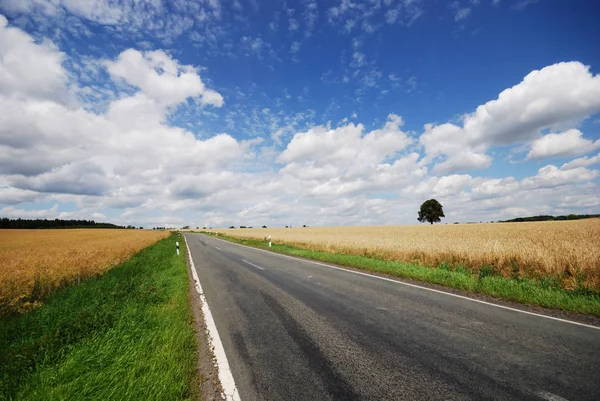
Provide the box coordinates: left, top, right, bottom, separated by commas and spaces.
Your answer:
0, 0, 600, 227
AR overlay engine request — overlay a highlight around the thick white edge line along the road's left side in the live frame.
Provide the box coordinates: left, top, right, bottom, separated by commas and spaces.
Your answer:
184, 236, 241, 401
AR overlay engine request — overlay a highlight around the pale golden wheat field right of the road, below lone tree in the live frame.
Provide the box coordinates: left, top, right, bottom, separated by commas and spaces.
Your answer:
213, 219, 600, 290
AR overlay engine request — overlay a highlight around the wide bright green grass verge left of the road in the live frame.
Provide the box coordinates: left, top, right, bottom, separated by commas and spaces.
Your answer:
0, 235, 197, 400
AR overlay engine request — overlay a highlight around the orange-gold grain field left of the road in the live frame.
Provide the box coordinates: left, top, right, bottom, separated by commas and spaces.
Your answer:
0, 229, 169, 312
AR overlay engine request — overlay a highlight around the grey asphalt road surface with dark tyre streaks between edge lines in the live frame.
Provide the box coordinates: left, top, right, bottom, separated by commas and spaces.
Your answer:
185, 234, 600, 401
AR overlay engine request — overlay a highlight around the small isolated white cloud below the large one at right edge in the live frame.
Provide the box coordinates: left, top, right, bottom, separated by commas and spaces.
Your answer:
527, 129, 600, 159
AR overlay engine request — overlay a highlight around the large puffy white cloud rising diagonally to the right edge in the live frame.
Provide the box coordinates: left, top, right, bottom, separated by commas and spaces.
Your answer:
420, 62, 600, 173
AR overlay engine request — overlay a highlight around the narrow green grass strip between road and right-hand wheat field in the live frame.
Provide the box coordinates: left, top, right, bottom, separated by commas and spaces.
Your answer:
205, 231, 600, 316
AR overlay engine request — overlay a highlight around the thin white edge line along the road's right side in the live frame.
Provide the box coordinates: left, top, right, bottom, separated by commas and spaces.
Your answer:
206, 233, 600, 330
